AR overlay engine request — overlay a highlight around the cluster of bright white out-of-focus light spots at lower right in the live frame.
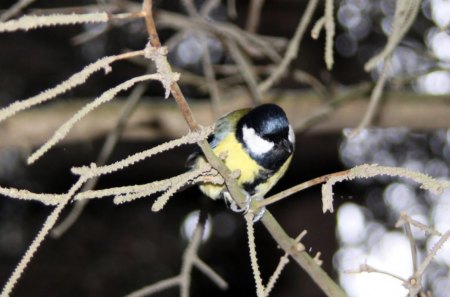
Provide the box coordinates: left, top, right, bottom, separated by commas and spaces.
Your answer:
334, 129, 450, 297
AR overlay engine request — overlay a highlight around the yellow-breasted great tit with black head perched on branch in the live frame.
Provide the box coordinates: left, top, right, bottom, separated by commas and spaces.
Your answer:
188, 104, 295, 210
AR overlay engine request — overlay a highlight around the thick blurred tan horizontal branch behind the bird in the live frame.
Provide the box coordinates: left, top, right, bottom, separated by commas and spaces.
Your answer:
0, 85, 450, 148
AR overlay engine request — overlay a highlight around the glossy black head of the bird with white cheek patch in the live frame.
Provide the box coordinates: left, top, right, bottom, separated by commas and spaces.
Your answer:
236, 104, 295, 170
